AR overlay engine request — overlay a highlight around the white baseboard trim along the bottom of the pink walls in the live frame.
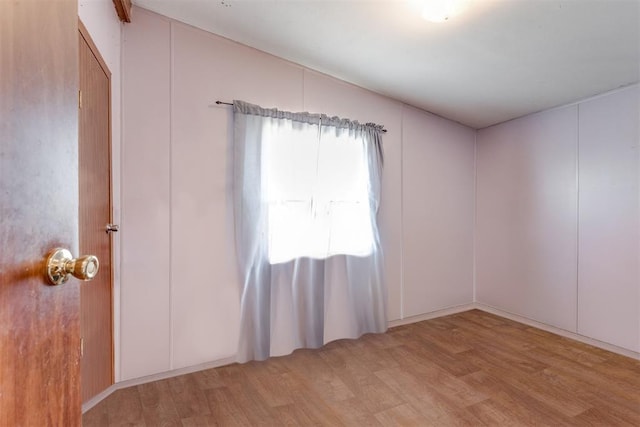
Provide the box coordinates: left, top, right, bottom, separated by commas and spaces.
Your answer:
82, 302, 640, 413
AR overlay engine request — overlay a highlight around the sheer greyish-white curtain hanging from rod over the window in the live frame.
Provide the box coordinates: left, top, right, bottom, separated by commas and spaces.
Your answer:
233, 101, 387, 362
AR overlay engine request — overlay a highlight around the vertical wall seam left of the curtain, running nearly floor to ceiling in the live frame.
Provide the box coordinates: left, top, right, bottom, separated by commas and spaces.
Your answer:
169, 22, 174, 369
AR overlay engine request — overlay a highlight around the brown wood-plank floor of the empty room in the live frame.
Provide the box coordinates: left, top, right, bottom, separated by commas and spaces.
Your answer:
83, 310, 640, 427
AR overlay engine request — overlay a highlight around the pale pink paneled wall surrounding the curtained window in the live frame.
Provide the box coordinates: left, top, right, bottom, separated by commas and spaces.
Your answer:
120, 9, 474, 380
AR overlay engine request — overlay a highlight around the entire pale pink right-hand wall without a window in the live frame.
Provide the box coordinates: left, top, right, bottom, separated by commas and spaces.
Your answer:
476, 85, 640, 352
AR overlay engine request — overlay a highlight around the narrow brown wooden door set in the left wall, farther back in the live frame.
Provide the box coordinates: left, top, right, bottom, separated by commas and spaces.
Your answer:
78, 22, 113, 402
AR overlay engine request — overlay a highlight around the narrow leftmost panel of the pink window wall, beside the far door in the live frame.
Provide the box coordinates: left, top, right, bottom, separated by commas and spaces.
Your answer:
120, 9, 172, 380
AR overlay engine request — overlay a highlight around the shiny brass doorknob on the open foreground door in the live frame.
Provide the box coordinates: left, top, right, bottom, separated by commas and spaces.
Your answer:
47, 248, 100, 286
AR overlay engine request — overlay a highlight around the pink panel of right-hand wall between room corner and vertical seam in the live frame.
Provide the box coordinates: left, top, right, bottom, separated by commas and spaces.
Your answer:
476, 107, 578, 332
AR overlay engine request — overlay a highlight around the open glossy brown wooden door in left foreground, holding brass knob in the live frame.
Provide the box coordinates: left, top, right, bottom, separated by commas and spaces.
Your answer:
0, 0, 81, 426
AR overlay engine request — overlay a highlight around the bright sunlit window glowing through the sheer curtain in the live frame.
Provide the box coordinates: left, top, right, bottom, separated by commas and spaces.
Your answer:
262, 121, 374, 264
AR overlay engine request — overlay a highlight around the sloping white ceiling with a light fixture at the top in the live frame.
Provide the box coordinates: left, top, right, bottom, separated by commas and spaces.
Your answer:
132, 0, 640, 128
